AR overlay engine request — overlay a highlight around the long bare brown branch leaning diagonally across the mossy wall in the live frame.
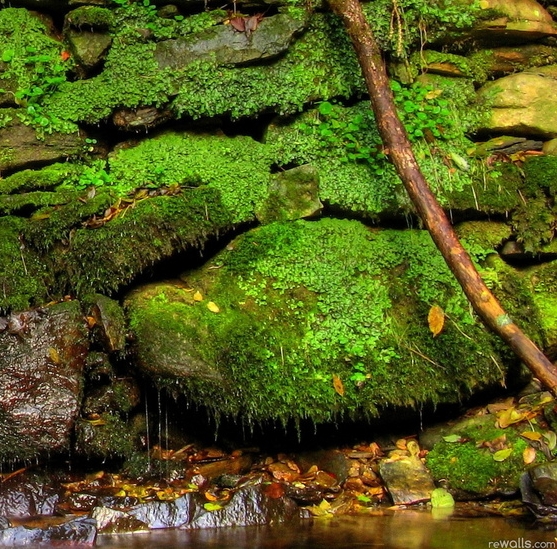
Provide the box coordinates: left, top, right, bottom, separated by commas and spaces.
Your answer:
329, 0, 557, 395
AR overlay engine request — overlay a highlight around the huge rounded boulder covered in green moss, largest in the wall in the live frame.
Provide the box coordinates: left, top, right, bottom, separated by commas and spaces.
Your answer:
126, 219, 516, 422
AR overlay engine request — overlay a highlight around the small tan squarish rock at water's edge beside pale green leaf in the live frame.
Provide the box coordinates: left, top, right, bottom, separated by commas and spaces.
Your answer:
379, 456, 435, 505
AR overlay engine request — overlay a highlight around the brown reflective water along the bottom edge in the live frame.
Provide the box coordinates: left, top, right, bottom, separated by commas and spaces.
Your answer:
98, 511, 557, 549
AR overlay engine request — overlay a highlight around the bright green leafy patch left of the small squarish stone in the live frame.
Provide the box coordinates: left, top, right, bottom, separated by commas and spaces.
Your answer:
109, 132, 272, 222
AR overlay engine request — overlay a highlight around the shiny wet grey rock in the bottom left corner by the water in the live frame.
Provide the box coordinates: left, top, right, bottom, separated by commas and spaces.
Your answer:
0, 517, 97, 547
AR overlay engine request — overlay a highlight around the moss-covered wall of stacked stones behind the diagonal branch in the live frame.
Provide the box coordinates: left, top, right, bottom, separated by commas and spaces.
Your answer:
0, 0, 557, 459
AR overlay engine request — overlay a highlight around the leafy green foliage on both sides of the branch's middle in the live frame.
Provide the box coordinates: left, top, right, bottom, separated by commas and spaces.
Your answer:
266, 94, 521, 217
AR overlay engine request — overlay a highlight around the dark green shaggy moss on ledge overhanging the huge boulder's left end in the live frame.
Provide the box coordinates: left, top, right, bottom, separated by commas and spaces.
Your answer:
54, 189, 232, 294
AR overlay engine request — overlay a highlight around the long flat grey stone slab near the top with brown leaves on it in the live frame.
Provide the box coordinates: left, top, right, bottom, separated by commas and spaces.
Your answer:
155, 14, 305, 70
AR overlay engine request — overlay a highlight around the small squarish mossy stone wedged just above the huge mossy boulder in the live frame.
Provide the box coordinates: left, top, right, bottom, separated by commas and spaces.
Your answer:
257, 165, 323, 223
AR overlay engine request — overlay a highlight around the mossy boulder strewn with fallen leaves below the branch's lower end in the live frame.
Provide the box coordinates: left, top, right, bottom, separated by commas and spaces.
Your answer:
420, 393, 555, 499
